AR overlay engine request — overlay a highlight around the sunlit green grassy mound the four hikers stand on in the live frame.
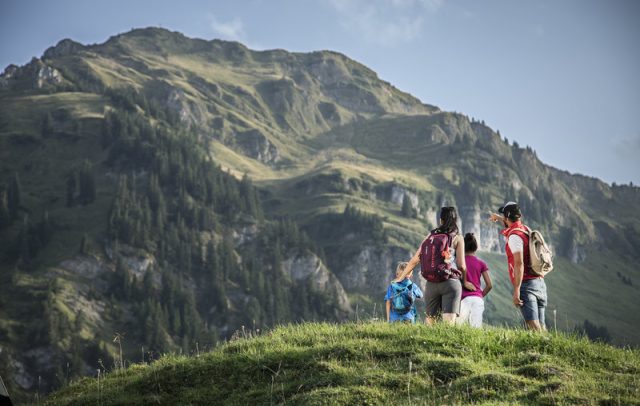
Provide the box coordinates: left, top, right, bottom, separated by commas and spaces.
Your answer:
46, 323, 640, 405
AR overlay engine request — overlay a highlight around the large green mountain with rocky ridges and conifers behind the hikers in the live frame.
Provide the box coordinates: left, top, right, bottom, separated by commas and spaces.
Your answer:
0, 28, 640, 402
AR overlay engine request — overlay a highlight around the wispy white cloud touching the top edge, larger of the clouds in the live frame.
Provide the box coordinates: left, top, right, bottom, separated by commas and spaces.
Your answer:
330, 0, 444, 46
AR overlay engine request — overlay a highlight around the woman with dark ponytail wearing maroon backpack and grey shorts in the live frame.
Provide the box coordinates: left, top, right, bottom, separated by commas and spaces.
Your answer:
396, 207, 475, 325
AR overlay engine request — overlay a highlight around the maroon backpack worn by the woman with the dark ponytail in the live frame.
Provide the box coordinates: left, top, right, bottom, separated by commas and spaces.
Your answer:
420, 231, 458, 282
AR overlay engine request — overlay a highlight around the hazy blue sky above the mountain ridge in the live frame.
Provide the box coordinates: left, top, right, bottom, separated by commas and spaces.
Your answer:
0, 0, 640, 185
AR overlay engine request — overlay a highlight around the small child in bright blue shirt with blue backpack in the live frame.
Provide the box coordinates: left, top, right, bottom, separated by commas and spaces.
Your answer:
384, 262, 422, 323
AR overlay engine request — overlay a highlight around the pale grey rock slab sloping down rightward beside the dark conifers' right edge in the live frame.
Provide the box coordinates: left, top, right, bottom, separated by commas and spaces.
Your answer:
282, 253, 351, 313
